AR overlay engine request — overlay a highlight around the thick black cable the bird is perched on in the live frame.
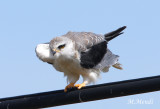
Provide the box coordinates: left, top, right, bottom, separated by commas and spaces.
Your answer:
0, 76, 160, 109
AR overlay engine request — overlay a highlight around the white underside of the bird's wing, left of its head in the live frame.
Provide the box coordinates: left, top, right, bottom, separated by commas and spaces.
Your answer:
35, 43, 54, 64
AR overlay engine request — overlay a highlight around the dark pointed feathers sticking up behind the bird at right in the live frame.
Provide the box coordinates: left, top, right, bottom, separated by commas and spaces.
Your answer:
104, 26, 126, 42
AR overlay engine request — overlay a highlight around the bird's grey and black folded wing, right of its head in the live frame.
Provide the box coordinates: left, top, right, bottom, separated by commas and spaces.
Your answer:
63, 32, 107, 69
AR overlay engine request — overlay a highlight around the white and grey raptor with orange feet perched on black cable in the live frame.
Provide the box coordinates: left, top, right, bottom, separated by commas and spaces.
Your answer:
35, 26, 126, 92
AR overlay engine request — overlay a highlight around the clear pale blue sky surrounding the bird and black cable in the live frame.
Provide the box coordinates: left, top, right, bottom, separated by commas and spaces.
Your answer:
0, 0, 160, 109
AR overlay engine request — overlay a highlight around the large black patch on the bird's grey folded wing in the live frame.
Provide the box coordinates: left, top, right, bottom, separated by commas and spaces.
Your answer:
80, 41, 107, 69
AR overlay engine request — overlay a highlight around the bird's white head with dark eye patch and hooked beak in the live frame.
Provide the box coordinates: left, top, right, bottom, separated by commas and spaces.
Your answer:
49, 37, 75, 57
